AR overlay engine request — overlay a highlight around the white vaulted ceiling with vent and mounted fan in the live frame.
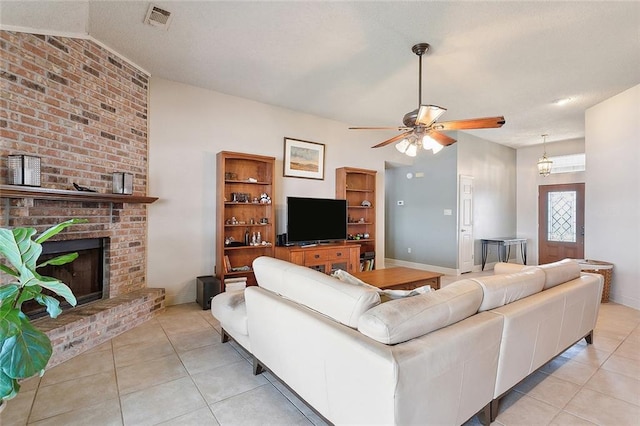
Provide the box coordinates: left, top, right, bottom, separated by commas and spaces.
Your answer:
0, 0, 640, 148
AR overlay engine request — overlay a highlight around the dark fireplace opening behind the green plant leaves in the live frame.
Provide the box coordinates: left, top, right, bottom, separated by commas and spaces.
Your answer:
22, 238, 109, 319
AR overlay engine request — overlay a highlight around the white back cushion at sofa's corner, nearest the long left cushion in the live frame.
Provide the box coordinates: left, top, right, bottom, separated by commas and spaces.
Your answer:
358, 280, 482, 344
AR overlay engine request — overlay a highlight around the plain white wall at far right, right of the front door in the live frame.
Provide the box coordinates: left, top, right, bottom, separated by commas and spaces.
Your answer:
585, 85, 640, 309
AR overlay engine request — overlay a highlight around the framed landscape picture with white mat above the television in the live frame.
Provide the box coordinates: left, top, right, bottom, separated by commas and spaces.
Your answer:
284, 138, 324, 180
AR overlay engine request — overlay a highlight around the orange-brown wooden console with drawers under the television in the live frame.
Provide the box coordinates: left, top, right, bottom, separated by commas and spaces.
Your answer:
276, 243, 360, 274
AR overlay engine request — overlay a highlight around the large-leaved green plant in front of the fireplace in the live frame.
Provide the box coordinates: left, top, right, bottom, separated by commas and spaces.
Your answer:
0, 219, 87, 405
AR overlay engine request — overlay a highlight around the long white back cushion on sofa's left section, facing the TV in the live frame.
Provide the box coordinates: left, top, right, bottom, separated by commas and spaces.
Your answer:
253, 256, 380, 328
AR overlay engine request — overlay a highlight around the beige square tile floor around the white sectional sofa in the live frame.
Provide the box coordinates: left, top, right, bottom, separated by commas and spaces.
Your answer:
0, 282, 640, 426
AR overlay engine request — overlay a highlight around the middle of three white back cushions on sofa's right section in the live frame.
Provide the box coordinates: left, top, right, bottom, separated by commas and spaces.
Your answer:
471, 266, 545, 312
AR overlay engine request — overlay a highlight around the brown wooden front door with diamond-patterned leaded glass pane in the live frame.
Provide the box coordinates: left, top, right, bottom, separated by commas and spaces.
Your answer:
538, 183, 584, 265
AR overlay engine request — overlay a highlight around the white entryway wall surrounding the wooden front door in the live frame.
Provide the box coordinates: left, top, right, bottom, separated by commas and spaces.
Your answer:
516, 139, 589, 265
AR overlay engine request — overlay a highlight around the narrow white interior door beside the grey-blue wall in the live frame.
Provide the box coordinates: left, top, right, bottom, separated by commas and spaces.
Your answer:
458, 175, 473, 274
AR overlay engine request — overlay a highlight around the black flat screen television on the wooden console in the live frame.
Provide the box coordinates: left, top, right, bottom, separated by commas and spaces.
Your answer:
287, 197, 347, 244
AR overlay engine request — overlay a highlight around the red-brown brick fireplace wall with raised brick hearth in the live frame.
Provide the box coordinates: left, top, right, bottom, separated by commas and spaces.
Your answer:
0, 31, 164, 367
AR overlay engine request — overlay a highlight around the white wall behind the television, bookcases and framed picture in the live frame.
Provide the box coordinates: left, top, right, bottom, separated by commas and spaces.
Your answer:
147, 78, 404, 304
